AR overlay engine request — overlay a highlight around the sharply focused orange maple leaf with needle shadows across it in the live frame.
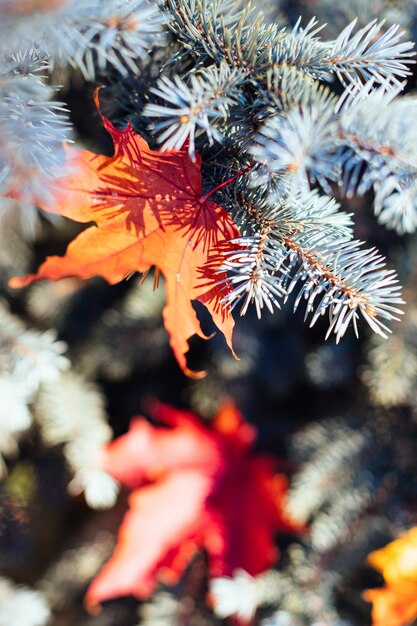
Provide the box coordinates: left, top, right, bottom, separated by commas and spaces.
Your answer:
10, 94, 239, 374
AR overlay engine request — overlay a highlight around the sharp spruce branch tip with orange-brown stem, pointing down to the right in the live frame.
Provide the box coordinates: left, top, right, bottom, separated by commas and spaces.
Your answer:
284, 235, 403, 342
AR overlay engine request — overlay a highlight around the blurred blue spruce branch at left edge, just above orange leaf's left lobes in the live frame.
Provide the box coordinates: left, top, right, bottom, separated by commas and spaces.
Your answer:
0, 48, 71, 202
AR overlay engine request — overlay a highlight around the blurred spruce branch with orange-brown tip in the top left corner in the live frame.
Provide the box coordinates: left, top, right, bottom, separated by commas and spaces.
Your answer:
0, 0, 163, 80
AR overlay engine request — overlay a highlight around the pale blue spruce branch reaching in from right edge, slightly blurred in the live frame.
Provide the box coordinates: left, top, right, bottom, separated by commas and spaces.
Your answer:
249, 74, 417, 234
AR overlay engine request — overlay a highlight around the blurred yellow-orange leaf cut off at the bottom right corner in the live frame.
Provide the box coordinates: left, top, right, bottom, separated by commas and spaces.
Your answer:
363, 528, 417, 626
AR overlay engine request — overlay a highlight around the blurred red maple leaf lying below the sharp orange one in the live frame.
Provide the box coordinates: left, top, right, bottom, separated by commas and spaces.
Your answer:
86, 404, 300, 608
